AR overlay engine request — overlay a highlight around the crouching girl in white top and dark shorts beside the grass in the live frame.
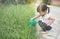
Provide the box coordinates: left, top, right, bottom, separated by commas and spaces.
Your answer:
33, 4, 55, 33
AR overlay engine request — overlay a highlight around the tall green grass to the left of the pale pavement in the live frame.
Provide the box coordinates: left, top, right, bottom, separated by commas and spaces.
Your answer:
0, 4, 37, 39
